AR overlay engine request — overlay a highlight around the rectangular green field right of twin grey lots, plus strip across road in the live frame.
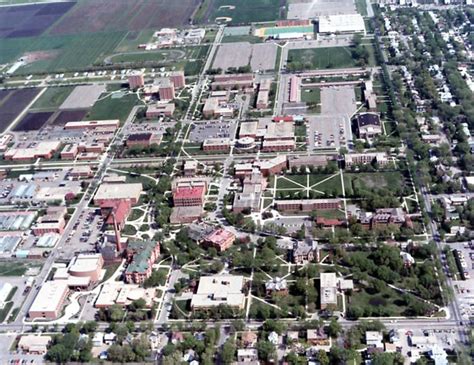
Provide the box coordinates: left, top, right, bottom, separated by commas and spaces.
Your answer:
288, 46, 375, 70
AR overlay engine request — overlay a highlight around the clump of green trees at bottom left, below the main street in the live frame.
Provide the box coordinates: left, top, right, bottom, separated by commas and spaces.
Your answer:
46, 322, 97, 364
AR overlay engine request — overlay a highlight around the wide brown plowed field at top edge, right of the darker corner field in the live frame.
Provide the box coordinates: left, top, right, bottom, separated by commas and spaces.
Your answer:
51, 0, 199, 35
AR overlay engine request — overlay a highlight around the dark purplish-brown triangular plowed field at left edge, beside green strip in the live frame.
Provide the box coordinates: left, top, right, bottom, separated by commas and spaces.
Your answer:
0, 89, 41, 132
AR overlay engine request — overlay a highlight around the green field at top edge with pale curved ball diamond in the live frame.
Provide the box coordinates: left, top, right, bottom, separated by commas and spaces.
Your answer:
203, 0, 284, 24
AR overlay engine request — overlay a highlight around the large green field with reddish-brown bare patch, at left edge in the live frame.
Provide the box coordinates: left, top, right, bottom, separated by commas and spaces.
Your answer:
0, 31, 126, 74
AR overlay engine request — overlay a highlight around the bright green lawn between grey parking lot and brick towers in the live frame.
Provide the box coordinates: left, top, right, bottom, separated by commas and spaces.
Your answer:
85, 94, 142, 123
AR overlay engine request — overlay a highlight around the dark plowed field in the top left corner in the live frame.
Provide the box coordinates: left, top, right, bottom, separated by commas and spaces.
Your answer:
0, 2, 75, 38
